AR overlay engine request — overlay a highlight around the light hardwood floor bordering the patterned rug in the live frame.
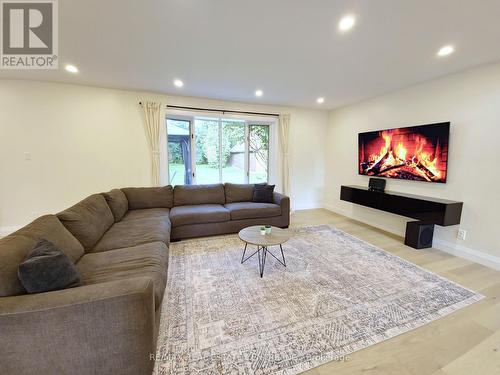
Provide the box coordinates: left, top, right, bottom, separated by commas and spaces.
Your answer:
292, 209, 500, 375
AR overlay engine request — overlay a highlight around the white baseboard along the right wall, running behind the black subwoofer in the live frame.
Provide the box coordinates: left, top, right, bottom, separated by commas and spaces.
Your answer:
324, 204, 500, 270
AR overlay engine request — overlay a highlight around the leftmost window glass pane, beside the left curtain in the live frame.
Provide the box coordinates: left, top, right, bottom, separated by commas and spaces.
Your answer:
167, 119, 192, 185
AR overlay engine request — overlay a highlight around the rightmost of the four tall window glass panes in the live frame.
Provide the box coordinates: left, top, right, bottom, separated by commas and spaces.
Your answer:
249, 125, 269, 184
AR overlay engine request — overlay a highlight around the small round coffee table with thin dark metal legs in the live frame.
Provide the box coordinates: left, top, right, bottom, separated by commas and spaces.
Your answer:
238, 225, 292, 277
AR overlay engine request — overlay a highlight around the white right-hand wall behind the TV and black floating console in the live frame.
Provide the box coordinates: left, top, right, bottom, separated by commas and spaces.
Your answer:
325, 64, 500, 267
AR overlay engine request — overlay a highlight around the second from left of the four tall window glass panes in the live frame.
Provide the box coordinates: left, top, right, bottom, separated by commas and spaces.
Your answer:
195, 118, 220, 184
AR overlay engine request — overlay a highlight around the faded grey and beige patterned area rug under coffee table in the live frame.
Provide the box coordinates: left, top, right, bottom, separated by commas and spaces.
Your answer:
155, 225, 482, 375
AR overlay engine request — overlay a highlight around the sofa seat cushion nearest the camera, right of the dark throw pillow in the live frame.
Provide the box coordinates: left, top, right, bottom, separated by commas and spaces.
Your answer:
76, 242, 168, 308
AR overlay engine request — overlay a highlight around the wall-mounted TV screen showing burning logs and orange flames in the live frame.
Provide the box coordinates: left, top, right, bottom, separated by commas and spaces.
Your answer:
358, 122, 450, 183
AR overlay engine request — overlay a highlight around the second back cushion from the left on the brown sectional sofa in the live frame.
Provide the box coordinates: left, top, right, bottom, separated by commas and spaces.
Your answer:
57, 194, 115, 250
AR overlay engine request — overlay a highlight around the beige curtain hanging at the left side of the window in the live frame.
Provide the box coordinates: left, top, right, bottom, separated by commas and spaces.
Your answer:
142, 102, 161, 186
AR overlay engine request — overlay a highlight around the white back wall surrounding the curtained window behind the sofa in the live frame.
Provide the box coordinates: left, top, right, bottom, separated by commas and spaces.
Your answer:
0, 80, 328, 233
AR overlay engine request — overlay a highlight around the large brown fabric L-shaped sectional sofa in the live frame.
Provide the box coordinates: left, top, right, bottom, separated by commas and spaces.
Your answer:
0, 184, 290, 375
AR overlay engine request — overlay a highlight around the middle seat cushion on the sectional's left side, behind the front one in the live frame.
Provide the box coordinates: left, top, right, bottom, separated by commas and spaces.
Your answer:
91, 217, 170, 253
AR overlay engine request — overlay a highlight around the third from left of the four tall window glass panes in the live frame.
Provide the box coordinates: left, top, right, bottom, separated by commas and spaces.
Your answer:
222, 120, 246, 184
